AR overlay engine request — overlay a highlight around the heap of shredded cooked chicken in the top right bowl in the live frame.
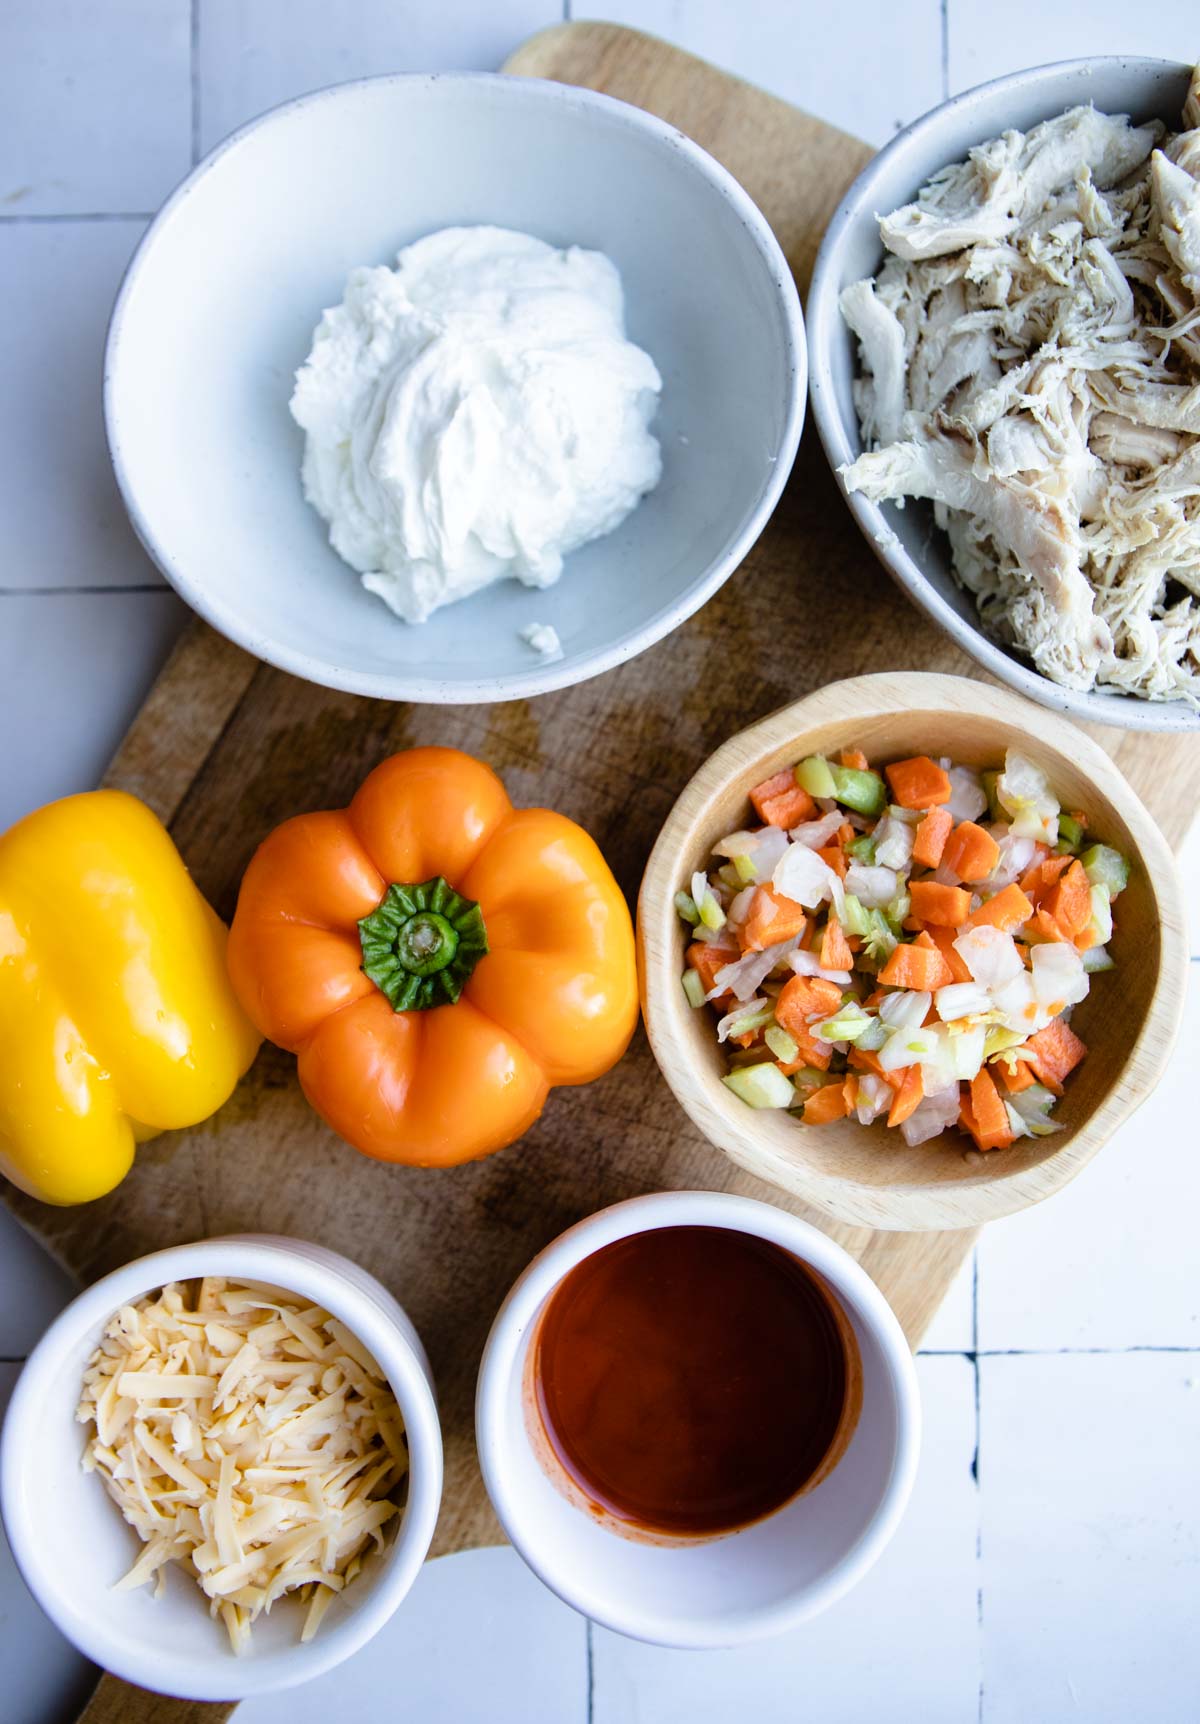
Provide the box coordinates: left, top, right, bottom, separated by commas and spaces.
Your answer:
840, 67, 1200, 707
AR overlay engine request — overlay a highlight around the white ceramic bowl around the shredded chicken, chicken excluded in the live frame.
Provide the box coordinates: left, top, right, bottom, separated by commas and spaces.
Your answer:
807, 57, 1200, 731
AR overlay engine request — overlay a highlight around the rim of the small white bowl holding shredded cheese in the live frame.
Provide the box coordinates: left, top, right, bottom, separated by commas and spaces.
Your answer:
0, 1234, 443, 1700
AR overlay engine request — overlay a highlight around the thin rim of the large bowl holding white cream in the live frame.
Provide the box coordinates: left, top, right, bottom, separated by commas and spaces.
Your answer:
103, 72, 809, 705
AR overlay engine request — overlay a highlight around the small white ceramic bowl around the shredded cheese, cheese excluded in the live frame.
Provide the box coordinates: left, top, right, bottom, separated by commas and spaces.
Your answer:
0, 1236, 441, 1700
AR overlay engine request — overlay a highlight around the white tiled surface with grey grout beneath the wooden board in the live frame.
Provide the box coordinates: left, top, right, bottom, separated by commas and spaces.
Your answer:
0, 0, 1200, 1724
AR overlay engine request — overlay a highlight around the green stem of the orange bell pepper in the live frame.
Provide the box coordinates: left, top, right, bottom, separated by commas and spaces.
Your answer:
359, 874, 488, 1012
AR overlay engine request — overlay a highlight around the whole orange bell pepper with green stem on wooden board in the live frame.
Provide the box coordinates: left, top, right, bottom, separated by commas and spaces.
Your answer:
229, 748, 638, 1167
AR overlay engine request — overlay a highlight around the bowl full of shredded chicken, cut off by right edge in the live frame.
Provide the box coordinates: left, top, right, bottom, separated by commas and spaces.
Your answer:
809, 59, 1200, 729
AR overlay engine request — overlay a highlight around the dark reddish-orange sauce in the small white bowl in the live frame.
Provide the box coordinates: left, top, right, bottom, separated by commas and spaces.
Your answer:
531, 1227, 857, 1538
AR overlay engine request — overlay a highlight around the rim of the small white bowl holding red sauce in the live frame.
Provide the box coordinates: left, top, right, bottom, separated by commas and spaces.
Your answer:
476, 1191, 921, 1652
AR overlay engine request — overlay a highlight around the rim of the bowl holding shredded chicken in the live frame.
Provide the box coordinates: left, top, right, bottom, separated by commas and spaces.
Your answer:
805, 53, 1200, 733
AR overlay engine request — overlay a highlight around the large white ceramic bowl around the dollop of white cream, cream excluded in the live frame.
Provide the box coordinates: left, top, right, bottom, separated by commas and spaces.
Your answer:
105, 74, 805, 702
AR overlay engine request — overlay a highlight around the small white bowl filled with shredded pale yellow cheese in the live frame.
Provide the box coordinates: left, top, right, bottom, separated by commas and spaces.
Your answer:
2, 1240, 441, 1700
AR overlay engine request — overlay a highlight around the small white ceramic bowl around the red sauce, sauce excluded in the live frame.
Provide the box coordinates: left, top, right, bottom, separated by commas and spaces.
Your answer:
476, 1191, 921, 1648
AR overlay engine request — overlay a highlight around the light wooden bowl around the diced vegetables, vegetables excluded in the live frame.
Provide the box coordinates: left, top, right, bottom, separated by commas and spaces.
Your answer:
638, 674, 1188, 1231
